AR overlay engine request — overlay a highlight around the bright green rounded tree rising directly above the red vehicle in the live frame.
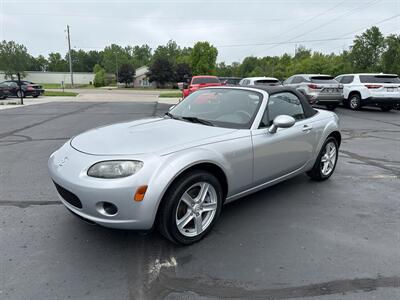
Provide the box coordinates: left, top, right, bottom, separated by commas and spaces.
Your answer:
190, 42, 218, 75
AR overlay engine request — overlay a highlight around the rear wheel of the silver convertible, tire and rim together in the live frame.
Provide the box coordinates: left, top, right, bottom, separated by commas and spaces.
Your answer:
307, 137, 339, 181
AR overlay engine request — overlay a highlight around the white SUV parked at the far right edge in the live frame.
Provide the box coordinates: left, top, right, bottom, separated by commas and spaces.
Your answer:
336, 73, 400, 111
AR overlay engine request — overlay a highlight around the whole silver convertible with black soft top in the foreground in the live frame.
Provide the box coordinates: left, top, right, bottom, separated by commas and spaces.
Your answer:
48, 87, 341, 244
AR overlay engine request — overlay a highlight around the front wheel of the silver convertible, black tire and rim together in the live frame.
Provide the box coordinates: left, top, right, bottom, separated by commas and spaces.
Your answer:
157, 170, 223, 245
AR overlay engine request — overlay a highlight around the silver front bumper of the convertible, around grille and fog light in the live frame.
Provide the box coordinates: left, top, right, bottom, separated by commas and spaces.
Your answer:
48, 142, 159, 230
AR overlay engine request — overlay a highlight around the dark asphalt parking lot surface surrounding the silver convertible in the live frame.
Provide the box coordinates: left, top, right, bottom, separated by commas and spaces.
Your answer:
0, 102, 400, 299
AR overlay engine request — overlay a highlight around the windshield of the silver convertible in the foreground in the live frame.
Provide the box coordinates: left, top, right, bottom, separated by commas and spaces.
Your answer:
169, 89, 263, 129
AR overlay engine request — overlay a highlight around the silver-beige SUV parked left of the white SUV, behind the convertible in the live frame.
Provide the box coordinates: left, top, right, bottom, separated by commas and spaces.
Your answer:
283, 74, 343, 110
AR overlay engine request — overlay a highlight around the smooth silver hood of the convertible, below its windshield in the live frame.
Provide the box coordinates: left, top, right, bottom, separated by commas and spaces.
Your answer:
71, 118, 236, 155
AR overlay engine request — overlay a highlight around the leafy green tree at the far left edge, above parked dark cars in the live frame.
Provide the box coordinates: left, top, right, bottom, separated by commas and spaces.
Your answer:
0, 41, 31, 78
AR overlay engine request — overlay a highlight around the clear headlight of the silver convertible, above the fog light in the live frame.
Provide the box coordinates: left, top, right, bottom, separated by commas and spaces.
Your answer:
88, 160, 143, 179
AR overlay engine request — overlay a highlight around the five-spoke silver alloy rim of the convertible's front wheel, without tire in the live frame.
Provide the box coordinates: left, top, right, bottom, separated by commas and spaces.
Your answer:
175, 182, 218, 237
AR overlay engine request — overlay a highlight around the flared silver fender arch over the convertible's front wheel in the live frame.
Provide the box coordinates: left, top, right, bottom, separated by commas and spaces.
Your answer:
146, 148, 232, 227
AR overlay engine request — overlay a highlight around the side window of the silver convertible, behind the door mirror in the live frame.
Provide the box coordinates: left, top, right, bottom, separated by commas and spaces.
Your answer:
260, 92, 305, 127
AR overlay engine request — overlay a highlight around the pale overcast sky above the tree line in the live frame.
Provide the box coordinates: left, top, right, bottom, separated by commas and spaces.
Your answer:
0, 0, 400, 63
